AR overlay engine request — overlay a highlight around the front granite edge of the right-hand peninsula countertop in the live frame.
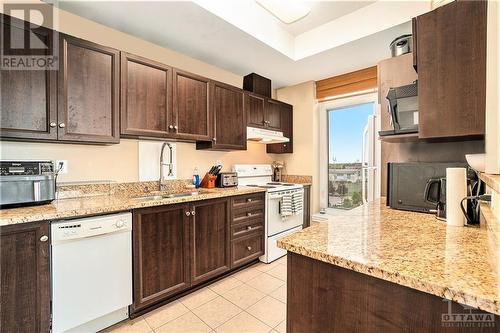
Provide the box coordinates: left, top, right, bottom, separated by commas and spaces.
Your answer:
277, 239, 500, 315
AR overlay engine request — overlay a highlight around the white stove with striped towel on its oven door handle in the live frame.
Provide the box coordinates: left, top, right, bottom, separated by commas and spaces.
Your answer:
233, 164, 304, 263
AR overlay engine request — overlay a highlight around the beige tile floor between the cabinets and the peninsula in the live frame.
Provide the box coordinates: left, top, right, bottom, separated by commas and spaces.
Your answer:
105, 257, 286, 333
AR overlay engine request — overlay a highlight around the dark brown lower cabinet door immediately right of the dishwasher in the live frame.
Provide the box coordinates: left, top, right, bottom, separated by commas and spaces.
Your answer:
132, 204, 190, 312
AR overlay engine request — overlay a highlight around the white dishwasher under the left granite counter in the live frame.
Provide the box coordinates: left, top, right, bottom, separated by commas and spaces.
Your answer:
51, 213, 132, 333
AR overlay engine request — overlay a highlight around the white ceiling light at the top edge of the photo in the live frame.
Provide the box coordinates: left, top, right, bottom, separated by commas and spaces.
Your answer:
255, 0, 311, 24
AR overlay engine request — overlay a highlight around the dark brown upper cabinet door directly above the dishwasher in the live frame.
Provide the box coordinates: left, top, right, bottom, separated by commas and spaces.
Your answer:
58, 35, 120, 143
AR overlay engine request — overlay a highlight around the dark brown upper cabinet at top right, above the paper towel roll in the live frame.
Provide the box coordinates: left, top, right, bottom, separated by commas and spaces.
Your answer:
413, 0, 487, 139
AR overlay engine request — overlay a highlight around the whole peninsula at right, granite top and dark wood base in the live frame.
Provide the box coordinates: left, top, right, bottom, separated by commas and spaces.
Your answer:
278, 199, 500, 332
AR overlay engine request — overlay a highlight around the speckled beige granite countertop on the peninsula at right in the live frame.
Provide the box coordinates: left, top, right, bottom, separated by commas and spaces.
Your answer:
278, 199, 500, 315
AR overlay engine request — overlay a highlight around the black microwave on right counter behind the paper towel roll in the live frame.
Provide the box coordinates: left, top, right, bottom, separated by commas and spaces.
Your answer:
386, 162, 467, 213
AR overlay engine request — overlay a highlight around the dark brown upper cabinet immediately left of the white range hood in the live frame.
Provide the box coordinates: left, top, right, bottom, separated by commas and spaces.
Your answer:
196, 82, 247, 150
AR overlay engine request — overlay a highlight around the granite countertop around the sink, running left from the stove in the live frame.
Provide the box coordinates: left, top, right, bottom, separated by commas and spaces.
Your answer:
0, 187, 265, 226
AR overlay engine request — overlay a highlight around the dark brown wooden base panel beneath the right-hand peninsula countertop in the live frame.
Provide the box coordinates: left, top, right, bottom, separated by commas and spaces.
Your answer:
286, 252, 500, 333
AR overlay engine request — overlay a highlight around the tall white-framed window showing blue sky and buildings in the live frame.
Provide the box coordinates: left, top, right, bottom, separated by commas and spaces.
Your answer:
319, 94, 380, 214
